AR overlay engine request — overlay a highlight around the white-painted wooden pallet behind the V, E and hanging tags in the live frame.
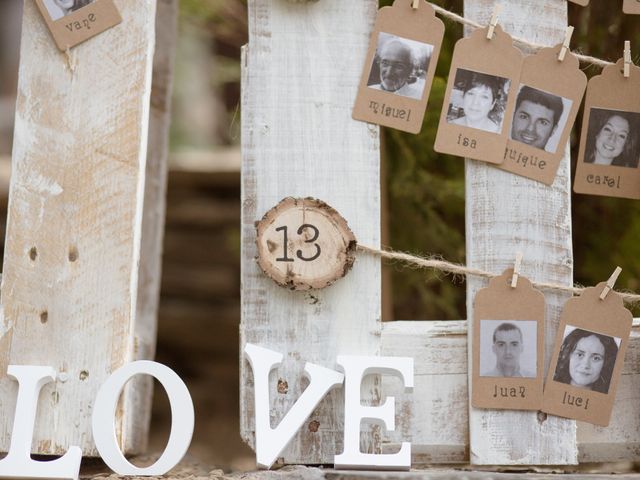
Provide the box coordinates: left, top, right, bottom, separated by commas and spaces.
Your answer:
241, 0, 640, 468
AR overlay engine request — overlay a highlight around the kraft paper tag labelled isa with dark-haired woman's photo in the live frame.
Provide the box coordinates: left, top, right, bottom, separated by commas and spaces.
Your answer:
434, 25, 523, 164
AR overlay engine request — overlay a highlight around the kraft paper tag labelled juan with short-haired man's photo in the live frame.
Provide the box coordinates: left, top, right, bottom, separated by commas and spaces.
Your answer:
471, 269, 545, 410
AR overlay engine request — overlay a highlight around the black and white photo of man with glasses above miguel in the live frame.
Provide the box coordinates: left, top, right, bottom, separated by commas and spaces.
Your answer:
367, 32, 433, 100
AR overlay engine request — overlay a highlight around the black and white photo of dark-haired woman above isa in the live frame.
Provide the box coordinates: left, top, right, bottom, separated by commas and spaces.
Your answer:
447, 68, 511, 133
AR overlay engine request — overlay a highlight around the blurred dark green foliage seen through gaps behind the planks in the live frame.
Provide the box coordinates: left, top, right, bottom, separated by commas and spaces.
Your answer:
180, 0, 640, 320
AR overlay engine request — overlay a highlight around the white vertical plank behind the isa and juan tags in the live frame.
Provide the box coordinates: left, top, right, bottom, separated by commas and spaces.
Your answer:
464, 0, 577, 465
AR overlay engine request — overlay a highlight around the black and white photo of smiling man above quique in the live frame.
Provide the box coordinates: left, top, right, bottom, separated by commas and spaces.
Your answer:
510, 84, 573, 153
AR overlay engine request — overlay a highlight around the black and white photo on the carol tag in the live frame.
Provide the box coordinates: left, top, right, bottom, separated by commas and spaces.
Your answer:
584, 108, 640, 168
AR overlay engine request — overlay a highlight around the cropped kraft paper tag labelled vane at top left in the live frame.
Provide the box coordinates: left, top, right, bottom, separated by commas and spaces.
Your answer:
35, 0, 122, 51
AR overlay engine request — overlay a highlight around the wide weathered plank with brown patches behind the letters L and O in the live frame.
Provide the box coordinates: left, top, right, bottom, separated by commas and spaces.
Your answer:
0, 0, 156, 456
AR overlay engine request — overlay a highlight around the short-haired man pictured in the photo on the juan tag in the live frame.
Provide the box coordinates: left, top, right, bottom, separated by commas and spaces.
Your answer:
480, 322, 536, 378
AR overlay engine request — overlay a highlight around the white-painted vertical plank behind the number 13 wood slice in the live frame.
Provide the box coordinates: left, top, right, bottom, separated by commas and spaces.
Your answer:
240, 0, 380, 464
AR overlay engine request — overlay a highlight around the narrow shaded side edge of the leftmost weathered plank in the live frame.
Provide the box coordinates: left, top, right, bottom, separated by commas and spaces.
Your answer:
123, 0, 178, 453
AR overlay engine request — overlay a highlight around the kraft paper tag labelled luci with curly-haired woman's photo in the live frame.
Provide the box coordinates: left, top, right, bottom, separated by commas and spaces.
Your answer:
542, 282, 633, 427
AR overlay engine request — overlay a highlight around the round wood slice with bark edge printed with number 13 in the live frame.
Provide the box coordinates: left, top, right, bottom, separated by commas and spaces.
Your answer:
256, 197, 356, 290
